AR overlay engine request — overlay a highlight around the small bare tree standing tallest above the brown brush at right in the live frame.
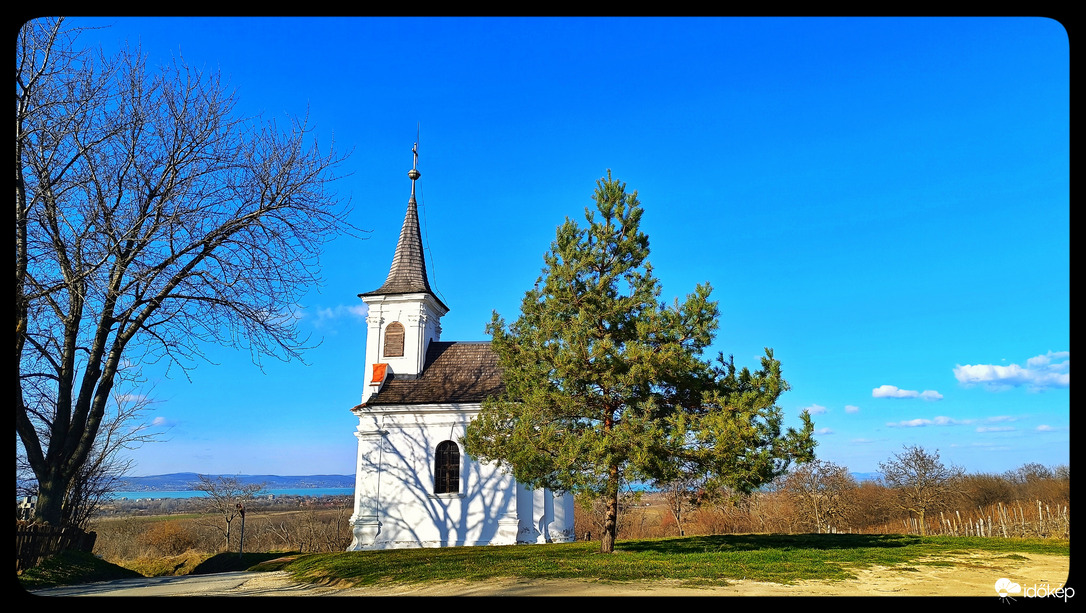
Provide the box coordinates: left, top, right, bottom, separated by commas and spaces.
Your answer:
879, 446, 964, 536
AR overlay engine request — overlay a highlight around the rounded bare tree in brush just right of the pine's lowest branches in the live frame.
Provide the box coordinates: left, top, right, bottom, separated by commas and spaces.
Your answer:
781, 460, 857, 534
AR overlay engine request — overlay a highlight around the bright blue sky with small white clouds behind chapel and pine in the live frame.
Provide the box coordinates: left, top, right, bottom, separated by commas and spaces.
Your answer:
44, 17, 1070, 475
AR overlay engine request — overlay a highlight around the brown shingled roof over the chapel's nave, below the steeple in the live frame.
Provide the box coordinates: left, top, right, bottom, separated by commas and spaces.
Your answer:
366, 341, 505, 406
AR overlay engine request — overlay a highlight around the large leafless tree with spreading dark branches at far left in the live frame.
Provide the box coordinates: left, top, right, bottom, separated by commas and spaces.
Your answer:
15, 20, 349, 524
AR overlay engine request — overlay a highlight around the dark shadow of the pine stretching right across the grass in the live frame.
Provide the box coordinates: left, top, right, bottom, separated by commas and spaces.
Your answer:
615, 534, 921, 553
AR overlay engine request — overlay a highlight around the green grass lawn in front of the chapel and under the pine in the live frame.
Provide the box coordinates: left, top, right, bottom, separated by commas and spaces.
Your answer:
253, 535, 1070, 586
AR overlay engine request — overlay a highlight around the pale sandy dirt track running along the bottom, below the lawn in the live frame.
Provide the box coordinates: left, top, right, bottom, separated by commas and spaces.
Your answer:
33, 554, 1070, 598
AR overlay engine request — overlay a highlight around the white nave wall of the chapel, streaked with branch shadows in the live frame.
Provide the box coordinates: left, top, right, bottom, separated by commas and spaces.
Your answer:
349, 404, 574, 550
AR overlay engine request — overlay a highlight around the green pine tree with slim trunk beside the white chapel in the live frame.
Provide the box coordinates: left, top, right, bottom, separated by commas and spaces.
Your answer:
464, 171, 815, 552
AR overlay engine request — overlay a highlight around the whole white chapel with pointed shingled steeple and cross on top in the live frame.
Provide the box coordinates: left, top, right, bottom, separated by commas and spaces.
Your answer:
348, 148, 574, 551
